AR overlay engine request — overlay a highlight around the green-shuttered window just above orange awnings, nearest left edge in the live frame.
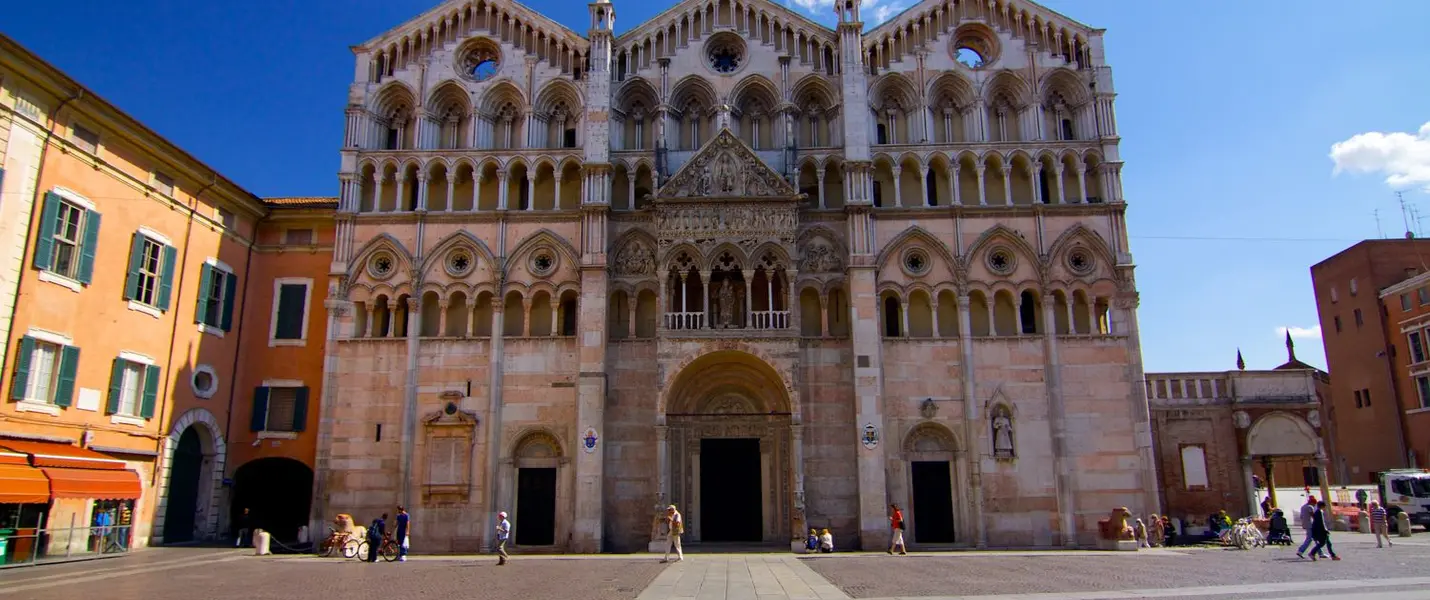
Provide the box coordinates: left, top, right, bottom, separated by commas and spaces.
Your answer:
10, 330, 80, 414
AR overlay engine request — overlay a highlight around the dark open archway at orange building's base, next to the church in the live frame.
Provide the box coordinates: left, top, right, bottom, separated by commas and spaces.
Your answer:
229, 457, 313, 541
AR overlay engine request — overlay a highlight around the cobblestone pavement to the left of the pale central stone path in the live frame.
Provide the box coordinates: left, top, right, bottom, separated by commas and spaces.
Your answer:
0, 554, 665, 600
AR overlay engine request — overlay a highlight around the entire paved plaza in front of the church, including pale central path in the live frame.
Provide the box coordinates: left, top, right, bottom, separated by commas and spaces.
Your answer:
0, 534, 1430, 600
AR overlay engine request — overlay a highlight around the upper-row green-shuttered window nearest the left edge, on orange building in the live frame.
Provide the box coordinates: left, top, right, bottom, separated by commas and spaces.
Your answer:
34, 187, 100, 291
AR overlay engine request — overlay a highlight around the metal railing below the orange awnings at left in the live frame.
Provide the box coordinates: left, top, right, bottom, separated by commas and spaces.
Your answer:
0, 514, 134, 569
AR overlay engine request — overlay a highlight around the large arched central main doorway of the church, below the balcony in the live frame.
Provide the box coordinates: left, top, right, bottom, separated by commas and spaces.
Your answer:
661, 350, 797, 544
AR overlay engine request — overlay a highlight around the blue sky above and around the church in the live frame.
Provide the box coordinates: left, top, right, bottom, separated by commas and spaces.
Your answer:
0, 0, 1430, 371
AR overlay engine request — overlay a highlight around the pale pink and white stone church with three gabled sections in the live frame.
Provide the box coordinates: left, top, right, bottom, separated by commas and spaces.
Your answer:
313, 0, 1157, 553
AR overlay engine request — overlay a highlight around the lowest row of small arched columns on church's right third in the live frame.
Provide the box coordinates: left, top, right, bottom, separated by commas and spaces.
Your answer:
869, 290, 1115, 337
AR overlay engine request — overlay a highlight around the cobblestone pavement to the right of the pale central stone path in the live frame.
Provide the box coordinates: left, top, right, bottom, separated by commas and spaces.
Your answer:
801, 534, 1430, 599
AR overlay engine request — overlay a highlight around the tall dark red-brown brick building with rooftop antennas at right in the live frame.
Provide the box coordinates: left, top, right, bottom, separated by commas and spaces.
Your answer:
1311, 239, 1430, 484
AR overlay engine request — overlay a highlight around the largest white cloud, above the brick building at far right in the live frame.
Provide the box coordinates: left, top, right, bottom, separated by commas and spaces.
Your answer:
1331, 123, 1430, 191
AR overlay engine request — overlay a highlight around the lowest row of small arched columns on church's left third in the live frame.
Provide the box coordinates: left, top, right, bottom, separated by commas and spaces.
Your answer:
352, 290, 578, 339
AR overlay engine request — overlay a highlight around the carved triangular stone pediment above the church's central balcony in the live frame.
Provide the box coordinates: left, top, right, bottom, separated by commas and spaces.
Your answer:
656, 129, 799, 200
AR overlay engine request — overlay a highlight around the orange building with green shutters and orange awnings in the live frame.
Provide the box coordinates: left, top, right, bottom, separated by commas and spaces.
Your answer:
0, 36, 335, 561
